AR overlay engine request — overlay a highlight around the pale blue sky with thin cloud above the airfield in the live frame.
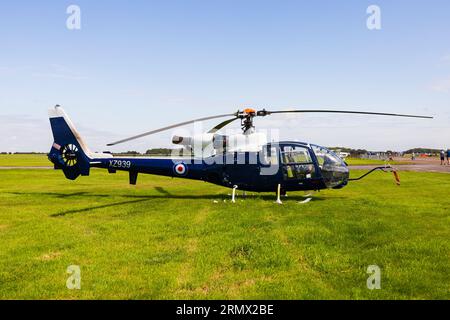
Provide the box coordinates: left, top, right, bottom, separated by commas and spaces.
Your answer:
0, 0, 450, 152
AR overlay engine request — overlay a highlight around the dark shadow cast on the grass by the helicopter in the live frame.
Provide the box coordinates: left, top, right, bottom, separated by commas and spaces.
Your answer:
8, 187, 341, 218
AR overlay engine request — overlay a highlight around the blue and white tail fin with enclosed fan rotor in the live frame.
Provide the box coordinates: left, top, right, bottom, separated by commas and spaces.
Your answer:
48, 105, 111, 180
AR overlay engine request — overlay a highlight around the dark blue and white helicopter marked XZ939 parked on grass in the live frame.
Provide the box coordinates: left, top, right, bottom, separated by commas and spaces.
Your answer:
48, 105, 433, 202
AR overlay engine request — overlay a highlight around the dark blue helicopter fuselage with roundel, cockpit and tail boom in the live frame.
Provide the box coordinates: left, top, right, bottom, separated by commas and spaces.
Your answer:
85, 141, 349, 192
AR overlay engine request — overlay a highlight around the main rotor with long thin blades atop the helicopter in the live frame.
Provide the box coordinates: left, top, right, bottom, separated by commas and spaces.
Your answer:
108, 108, 433, 146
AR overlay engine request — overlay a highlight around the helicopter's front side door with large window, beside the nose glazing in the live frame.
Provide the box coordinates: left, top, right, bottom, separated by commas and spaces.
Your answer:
281, 145, 316, 181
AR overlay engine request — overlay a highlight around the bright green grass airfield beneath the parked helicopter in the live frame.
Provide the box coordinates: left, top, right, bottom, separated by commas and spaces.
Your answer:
0, 155, 450, 299
